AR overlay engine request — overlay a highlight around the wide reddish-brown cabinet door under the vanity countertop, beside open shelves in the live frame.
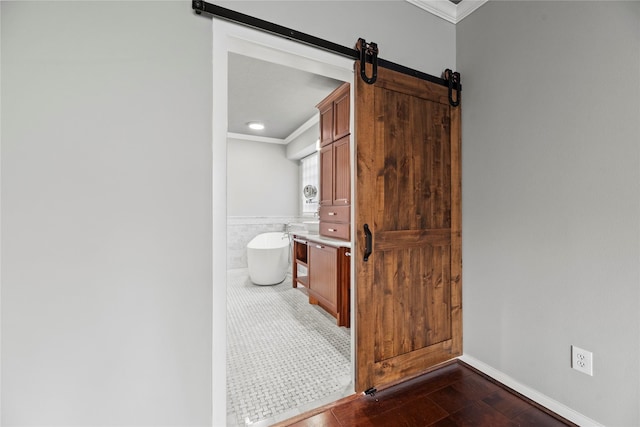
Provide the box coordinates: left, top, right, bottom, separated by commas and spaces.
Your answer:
309, 243, 338, 315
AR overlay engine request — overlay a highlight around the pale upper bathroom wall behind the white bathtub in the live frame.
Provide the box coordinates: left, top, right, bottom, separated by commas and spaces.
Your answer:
227, 139, 302, 216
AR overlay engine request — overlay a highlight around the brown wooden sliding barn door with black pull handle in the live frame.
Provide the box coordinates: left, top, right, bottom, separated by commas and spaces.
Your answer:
354, 62, 462, 391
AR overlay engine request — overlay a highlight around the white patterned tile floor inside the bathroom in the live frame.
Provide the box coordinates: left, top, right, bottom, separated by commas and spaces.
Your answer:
227, 269, 353, 427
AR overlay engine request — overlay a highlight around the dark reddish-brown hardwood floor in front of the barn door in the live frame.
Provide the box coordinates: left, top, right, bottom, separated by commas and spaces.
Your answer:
277, 361, 575, 427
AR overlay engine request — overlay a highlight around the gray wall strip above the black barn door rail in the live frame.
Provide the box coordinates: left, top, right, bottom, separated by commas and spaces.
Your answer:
214, 0, 456, 76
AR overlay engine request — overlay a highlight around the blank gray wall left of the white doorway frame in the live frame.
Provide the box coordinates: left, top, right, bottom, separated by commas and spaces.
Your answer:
0, 1, 214, 426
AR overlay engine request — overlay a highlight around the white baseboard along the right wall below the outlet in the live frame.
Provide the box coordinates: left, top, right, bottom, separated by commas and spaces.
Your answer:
458, 354, 604, 427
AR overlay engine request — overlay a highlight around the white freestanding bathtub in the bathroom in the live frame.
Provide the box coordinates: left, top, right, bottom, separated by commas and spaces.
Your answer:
247, 232, 289, 285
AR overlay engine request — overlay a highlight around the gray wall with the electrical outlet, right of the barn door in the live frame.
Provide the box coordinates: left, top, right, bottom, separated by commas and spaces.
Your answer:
457, 2, 640, 426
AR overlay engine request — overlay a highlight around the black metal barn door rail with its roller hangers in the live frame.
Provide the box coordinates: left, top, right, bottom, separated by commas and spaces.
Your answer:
191, 0, 462, 107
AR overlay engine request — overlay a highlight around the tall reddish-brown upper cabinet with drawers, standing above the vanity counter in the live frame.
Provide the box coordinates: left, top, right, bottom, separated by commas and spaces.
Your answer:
317, 83, 351, 240
